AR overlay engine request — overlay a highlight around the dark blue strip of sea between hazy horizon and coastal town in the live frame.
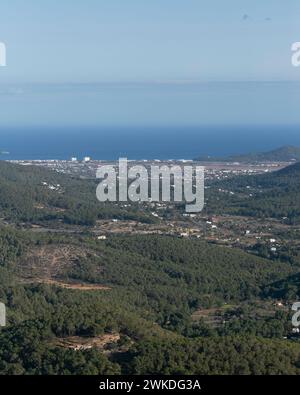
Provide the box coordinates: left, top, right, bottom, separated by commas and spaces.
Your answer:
0, 125, 300, 160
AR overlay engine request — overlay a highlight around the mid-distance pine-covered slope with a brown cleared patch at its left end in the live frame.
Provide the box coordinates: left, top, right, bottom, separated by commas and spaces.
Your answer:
9, 236, 294, 320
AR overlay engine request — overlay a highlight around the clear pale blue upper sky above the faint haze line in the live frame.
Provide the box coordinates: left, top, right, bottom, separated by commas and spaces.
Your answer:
0, 0, 300, 83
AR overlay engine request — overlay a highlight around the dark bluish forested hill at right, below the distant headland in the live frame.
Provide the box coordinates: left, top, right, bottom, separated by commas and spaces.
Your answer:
207, 162, 300, 223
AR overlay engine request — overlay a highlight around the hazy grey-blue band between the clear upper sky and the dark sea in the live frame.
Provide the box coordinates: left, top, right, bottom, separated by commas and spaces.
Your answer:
0, 82, 300, 131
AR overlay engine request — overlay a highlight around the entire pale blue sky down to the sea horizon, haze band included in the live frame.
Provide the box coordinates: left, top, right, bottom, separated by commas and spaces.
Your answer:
0, 0, 300, 132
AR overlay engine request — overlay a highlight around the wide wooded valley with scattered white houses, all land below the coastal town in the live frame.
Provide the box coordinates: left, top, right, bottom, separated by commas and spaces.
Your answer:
0, 152, 300, 374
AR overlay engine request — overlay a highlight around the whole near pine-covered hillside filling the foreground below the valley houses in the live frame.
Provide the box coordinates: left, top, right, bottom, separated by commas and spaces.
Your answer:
0, 228, 300, 375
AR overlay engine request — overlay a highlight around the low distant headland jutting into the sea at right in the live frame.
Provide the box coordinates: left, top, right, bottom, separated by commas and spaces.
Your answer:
195, 145, 300, 163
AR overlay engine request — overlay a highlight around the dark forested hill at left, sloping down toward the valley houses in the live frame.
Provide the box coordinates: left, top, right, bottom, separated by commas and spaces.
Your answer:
0, 161, 154, 226
